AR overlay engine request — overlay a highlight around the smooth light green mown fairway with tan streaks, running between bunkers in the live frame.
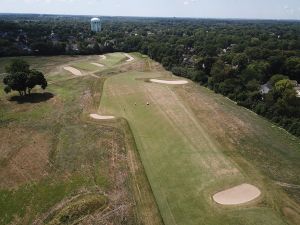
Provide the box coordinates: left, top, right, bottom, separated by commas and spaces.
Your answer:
99, 55, 284, 225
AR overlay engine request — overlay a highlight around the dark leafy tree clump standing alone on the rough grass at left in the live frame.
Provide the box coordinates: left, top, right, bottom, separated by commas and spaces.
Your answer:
3, 59, 47, 96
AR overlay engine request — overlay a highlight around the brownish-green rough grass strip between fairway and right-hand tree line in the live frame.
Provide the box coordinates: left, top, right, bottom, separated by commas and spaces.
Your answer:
187, 84, 300, 193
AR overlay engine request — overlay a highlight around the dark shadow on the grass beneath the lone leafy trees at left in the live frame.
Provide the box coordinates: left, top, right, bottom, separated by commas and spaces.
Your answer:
9, 92, 54, 104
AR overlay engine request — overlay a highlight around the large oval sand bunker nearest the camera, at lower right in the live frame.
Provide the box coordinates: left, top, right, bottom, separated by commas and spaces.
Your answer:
213, 184, 261, 205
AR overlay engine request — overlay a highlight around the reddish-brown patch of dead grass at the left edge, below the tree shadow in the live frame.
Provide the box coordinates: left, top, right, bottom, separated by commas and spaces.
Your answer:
0, 128, 51, 188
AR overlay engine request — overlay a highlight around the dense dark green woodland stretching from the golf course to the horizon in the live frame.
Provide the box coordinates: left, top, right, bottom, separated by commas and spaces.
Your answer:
0, 17, 300, 136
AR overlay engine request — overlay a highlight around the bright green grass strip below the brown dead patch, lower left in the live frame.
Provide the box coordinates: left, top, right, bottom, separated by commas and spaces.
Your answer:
0, 175, 93, 224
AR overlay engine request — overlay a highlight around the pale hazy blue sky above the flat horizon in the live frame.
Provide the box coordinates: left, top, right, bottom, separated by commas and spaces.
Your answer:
0, 0, 300, 19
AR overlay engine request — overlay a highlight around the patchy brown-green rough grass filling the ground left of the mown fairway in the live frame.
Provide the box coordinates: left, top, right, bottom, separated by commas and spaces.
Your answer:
0, 53, 161, 225
